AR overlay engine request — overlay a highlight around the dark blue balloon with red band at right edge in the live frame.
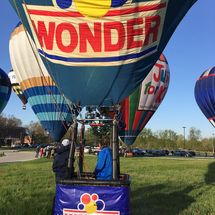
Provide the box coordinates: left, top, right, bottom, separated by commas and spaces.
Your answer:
195, 67, 215, 127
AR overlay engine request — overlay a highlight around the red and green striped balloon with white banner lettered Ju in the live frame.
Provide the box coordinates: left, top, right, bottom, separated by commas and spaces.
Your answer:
119, 54, 170, 145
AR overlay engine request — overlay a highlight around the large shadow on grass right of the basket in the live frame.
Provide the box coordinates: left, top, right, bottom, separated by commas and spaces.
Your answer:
132, 184, 195, 215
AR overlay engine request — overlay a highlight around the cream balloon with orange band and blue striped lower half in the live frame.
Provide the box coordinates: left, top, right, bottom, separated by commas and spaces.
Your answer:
9, 24, 72, 141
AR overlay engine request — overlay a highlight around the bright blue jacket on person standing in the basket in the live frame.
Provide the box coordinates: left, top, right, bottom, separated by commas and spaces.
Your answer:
95, 147, 113, 180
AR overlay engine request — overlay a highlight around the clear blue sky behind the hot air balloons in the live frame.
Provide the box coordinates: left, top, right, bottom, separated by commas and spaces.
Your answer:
0, 0, 215, 137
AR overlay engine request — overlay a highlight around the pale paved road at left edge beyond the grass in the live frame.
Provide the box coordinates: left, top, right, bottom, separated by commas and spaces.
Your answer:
0, 150, 36, 163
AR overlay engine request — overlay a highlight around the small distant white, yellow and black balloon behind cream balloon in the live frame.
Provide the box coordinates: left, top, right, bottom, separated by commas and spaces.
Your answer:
8, 70, 28, 110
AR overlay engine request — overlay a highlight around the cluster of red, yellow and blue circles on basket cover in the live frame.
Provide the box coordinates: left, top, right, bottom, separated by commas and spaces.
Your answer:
77, 193, 105, 214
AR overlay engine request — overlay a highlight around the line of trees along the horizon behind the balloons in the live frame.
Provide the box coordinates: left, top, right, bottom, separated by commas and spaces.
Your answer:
0, 115, 214, 152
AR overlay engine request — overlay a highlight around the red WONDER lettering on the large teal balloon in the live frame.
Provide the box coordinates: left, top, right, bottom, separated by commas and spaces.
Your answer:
32, 15, 161, 53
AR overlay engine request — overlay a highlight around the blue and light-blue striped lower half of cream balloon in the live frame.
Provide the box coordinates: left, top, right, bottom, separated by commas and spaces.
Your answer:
21, 80, 72, 141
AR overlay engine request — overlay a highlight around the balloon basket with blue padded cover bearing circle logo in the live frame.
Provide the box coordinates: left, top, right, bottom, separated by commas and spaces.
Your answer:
54, 173, 131, 215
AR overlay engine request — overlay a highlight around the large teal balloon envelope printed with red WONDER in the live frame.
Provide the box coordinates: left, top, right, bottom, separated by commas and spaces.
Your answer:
10, 0, 196, 106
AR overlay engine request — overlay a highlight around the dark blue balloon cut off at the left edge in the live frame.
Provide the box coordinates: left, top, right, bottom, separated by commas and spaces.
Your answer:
0, 69, 11, 114
